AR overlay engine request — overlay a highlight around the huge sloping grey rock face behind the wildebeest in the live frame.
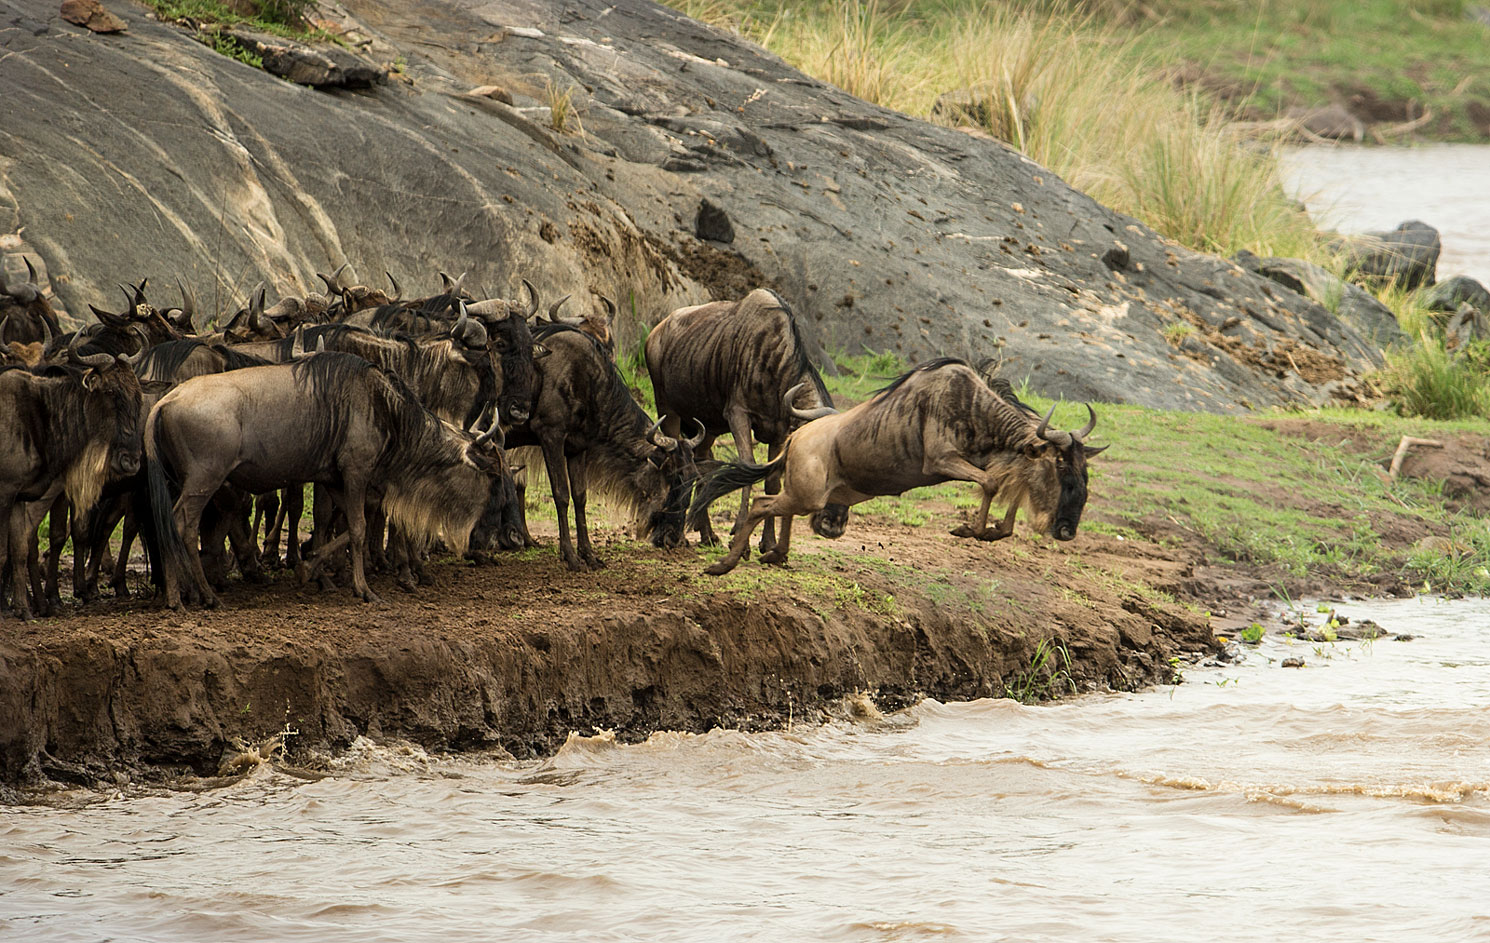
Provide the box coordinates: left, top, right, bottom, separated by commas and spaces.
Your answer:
0, 0, 1394, 411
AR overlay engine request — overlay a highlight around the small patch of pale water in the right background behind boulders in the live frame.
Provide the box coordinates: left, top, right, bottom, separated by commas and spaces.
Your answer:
1281, 145, 1490, 285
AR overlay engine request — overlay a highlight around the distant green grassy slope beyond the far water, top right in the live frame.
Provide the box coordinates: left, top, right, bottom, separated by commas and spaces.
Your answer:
1125, 0, 1490, 140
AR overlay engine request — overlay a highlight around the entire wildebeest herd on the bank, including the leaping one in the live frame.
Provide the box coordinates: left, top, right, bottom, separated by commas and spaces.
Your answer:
0, 262, 1100, 618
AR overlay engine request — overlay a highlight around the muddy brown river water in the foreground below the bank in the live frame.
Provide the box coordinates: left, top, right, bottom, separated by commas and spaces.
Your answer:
0, 600, 1490, 943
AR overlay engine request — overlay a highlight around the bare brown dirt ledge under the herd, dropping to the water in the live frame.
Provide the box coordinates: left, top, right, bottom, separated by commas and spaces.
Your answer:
0, 523, 1211, 785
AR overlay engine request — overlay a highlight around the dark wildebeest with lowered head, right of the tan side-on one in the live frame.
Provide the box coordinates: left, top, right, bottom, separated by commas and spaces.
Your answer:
507, 322, 703, 571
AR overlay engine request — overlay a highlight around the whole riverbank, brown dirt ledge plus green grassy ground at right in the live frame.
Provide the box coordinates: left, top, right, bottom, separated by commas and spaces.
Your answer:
0, 407, 1490, 784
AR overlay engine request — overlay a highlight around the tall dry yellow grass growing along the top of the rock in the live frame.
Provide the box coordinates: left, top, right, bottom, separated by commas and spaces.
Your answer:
673, 0, 1322, 259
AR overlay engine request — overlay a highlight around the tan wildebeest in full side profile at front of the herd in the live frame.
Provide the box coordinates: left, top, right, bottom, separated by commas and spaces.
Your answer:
145, 353, 504, 608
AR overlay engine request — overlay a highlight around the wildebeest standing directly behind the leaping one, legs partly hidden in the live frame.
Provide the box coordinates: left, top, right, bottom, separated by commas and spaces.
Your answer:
647, 288, 848, 553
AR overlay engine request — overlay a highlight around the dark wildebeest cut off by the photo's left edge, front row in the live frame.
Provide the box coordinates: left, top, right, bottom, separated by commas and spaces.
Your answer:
0, 347, 140, 618
